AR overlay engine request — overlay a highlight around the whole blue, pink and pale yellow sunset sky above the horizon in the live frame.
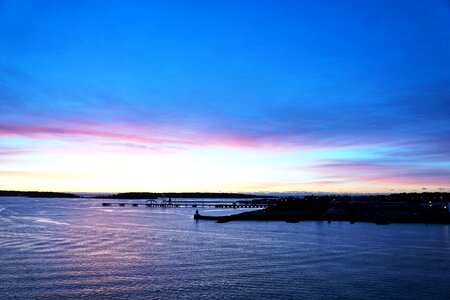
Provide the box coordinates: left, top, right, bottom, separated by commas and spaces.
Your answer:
0, 0, 450, 193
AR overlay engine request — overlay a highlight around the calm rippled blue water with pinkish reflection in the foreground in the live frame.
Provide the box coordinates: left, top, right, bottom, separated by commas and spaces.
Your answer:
0, 198, 450, 299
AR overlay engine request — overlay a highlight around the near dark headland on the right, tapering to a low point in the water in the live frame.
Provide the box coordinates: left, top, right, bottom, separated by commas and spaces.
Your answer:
194, 193, 450, 224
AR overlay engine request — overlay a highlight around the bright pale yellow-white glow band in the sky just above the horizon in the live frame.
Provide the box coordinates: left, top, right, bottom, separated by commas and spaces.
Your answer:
0, 136, 445, 193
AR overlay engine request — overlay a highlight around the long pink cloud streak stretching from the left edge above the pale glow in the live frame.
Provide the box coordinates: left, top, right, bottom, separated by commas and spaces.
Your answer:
0, 122, 330, 151
